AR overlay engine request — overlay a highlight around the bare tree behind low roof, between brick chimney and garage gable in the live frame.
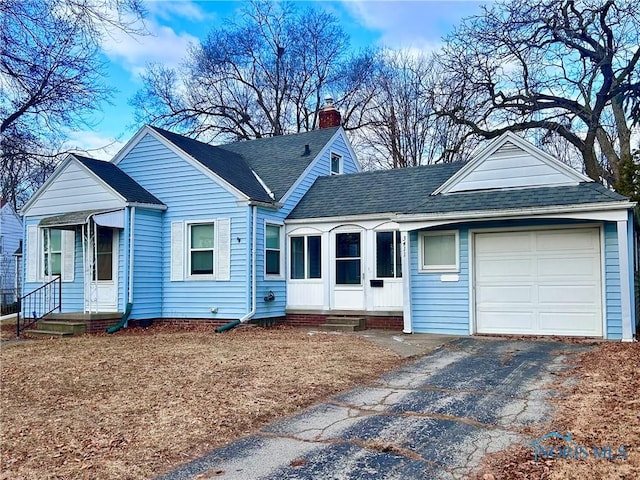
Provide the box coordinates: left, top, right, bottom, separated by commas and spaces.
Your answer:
356, 50, 475, 168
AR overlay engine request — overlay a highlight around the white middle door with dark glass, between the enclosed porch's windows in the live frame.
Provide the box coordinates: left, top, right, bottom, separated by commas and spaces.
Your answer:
333, 232, 365, 310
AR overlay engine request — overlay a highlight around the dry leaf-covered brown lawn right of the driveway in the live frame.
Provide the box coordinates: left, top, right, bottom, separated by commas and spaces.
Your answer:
476, 342, 640, 480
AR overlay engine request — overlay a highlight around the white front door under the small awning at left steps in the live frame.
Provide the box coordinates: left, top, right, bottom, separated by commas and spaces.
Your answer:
85, 227, 118, 312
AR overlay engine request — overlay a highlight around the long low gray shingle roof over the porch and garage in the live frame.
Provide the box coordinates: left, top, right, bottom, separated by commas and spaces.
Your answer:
288, 163, 626, 219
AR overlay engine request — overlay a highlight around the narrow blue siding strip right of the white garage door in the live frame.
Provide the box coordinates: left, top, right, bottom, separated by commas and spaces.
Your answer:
604, 222, 622, 339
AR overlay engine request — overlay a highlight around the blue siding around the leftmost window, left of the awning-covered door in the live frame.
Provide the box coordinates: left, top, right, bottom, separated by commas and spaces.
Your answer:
22, 217, 84, 314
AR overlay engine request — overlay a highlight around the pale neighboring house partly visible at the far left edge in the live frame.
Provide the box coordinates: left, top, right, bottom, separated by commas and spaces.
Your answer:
0, 199, 22, 305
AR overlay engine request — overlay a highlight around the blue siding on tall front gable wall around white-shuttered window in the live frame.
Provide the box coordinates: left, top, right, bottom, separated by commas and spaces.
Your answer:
118, 134, 251, 319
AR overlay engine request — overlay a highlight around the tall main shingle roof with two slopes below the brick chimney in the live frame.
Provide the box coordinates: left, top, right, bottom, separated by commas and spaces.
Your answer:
151, 127, 337, 202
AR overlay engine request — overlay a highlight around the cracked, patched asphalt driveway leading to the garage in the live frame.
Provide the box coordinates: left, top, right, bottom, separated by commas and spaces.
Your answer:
160, 338, 588, 480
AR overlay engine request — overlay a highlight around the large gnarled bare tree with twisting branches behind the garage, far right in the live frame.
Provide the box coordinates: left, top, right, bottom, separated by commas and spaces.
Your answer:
440, 0, 640, 191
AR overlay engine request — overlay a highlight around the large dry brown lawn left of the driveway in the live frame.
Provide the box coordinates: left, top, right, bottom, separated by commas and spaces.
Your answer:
0, 327, 401, 480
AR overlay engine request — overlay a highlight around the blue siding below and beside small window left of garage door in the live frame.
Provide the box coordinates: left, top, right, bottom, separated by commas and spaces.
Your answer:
409, 227, 469, 335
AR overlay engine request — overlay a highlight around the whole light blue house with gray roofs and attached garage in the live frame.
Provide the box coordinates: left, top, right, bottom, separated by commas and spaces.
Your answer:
18, 107, 637, 340
